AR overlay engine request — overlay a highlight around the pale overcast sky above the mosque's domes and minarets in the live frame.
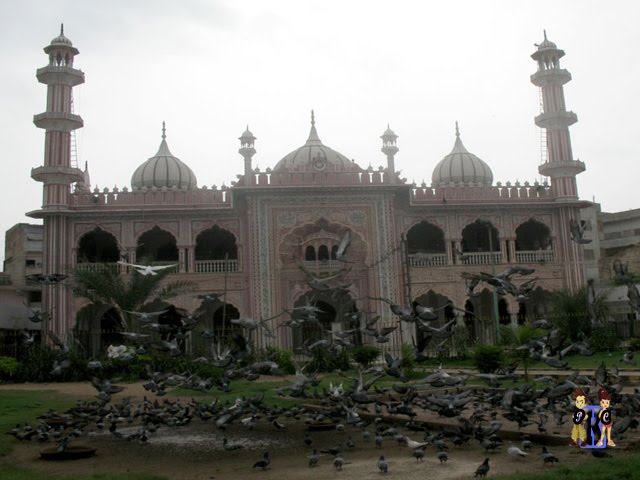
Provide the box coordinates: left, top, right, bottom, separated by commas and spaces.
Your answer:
0, 0, 640, 264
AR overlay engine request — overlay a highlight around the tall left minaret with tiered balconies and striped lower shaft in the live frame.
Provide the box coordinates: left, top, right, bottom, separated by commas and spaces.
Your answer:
30, 26, 84, 333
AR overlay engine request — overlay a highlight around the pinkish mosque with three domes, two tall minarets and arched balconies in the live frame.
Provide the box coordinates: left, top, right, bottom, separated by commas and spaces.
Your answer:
28, 31, 590, 348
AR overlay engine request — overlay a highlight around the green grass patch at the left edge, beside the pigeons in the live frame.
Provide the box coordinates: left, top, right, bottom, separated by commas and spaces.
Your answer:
0, 390, 74, 454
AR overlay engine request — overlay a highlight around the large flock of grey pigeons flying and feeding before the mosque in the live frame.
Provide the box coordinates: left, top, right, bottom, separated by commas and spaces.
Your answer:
8, 221, 640, 478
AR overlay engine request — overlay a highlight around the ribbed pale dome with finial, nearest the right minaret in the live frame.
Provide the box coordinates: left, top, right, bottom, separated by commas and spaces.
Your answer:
431, 122, 493, 185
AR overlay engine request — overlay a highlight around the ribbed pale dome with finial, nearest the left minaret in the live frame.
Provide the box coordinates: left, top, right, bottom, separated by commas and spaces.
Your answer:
131, 122, 198, 190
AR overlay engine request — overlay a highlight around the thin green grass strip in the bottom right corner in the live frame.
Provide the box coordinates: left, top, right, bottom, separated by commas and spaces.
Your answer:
492, 454, 640, 480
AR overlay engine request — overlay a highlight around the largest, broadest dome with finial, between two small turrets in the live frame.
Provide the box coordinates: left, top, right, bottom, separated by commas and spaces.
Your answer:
273, 110, 363, 173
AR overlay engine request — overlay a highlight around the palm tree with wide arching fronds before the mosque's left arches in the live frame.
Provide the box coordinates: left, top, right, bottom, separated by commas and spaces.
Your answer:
71, 264, 194, 330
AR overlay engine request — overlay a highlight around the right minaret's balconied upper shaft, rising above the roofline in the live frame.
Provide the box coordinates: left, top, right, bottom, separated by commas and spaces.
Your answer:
531, 32, 585, 200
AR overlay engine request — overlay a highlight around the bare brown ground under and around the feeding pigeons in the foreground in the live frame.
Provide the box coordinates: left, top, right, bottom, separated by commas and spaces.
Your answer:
0, 383, 627, 480
